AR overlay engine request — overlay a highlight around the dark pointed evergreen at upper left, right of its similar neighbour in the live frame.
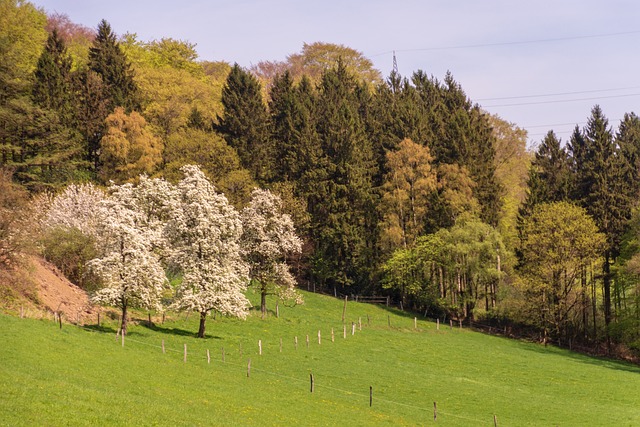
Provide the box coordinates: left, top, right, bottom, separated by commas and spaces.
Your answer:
89, 19, 140, 112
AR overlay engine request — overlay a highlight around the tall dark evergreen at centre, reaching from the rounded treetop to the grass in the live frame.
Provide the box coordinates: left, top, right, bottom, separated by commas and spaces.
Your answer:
311, 63, 377, 288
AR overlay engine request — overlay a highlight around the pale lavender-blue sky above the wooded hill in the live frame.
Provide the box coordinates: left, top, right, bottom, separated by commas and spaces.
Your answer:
32, 0, 640, 146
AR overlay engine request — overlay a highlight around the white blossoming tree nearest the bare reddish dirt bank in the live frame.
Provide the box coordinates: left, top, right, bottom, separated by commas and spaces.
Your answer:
88, 184, 167, 334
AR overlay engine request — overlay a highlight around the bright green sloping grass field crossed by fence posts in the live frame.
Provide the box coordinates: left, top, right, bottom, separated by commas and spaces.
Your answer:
0, 293, 640, 426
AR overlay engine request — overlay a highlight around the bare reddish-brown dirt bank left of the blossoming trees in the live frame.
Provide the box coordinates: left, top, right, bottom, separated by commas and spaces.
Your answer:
30, 256, 96, 322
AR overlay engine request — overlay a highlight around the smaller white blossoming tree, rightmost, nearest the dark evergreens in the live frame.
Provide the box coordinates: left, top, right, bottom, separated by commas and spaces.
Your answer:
242, 189, 302, 316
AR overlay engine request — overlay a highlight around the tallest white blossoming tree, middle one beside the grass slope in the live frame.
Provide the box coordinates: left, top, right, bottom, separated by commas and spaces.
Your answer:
166, 165, 251, 338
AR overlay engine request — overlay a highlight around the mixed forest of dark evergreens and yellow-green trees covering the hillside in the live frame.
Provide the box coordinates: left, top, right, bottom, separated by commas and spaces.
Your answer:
0, 0, 640, 358
